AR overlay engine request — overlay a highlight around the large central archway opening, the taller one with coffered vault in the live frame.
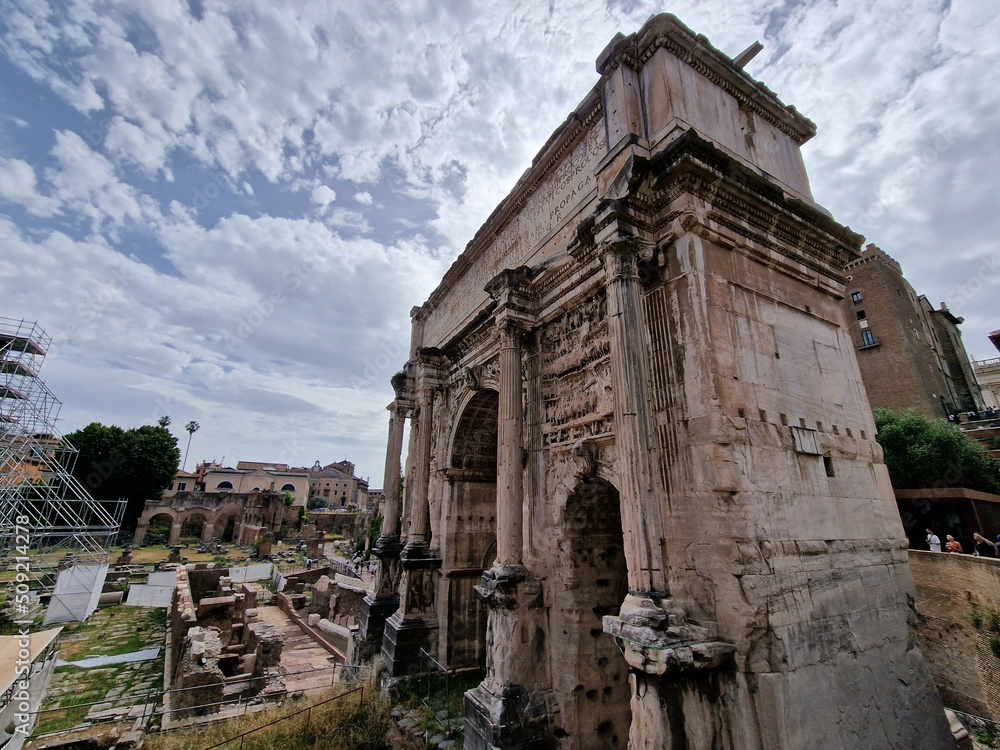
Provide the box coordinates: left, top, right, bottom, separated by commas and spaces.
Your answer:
443, 390, 500, 669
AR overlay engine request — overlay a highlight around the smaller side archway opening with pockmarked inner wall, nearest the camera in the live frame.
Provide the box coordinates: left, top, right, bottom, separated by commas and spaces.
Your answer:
551, 477, 631, 750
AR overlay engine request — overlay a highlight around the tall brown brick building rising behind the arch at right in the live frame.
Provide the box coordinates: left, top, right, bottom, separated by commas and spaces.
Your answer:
842, 244, 984, 424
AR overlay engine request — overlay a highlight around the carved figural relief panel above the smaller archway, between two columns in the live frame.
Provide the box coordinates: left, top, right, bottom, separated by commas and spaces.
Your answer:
539, 290, 614, 447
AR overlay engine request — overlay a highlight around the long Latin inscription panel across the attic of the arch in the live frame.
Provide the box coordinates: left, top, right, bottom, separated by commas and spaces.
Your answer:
424, 122, 607, 345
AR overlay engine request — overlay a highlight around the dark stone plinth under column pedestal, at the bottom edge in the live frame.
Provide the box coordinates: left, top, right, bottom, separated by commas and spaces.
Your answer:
465, 685, 556, 750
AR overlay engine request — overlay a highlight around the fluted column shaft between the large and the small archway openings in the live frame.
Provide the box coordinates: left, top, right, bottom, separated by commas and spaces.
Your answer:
497, 317, 524, 568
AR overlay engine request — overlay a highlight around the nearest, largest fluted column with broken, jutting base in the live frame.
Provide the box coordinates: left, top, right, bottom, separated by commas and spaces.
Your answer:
595, 217, 736, 748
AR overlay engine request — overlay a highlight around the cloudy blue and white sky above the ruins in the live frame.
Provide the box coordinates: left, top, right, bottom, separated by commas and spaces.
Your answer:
0, 0, 1000, 485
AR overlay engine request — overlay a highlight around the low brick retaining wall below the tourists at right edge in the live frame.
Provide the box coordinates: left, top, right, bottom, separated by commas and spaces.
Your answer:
909, 550, 1000, 721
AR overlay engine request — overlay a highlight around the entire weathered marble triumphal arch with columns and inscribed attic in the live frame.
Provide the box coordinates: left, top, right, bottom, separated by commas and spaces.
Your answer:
354, 11, 954, 750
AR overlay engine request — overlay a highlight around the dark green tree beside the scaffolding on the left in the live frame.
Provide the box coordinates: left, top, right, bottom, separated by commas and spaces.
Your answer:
66, 418, 181, 530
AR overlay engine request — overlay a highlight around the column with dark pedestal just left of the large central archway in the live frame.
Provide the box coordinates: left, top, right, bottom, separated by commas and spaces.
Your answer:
382, 348, 445, 677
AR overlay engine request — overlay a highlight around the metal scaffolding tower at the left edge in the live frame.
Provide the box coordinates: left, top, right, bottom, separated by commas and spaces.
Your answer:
0, 317, 125, 624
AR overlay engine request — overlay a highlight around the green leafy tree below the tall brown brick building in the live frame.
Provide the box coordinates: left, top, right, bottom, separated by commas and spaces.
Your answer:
874, 408, 1000, 492
